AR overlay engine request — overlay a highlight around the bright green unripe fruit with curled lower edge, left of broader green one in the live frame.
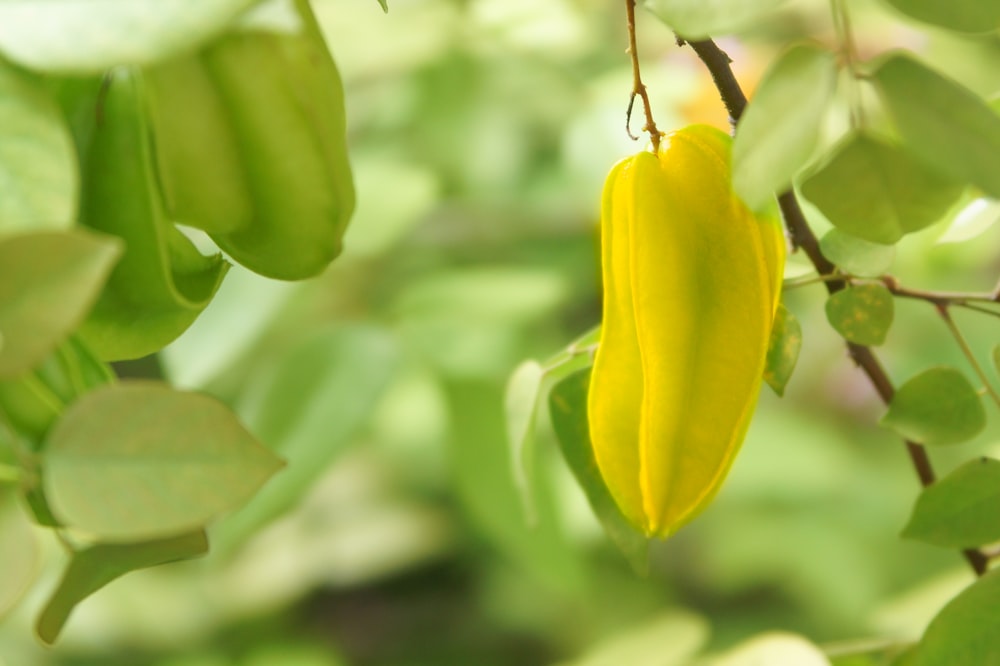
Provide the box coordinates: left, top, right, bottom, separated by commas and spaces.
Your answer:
69, 68, 229, 360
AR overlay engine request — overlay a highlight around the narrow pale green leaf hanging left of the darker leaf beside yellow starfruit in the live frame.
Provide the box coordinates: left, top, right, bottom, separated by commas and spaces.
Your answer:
504, 360, 545, 523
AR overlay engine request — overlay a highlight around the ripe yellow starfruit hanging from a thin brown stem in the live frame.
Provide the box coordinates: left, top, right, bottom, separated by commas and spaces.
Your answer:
588, 125, 785, 538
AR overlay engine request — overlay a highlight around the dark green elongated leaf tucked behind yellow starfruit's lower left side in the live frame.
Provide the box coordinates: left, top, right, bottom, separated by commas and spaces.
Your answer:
549, 368, 649, 573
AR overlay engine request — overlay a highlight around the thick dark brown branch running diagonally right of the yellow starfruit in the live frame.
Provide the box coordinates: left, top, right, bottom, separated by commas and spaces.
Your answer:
678, 37, 988, 576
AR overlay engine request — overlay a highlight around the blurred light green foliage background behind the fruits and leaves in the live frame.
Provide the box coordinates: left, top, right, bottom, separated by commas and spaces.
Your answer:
0, 0, 1000, 666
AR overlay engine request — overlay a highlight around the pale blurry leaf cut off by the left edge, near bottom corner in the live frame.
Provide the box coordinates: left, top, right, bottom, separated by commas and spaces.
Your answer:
0, 493, 42, 618
